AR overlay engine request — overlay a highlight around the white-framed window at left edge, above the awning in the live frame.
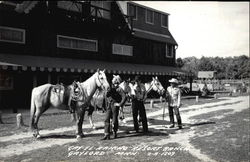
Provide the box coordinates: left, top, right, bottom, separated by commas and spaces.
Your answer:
0, 26, 25, 44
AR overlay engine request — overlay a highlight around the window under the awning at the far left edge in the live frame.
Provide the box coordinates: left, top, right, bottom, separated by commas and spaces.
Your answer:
0, 72, 13, 90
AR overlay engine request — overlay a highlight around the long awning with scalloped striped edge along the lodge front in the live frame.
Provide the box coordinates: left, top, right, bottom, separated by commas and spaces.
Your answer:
0, 54, 192, 76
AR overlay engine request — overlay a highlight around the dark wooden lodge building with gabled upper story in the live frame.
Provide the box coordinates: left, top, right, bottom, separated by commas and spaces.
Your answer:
0, 1, 191, 111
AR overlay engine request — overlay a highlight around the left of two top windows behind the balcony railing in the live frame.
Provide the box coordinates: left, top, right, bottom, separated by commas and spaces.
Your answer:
57, 1, 82, 12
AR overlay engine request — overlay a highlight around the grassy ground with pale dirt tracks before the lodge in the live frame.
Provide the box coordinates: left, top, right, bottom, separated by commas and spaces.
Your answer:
0, 96, 250, 162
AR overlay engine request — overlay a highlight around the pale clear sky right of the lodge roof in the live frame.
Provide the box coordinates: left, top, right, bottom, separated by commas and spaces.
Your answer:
136, 1, 249, 58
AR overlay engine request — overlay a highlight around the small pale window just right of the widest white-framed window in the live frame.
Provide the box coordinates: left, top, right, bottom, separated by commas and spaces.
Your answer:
112, 44, 133, 56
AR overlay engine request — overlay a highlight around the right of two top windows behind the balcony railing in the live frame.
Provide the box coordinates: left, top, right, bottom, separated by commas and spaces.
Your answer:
91, 1, 111, 19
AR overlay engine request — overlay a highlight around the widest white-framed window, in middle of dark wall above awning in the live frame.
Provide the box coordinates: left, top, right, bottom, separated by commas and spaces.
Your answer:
57, 35, 98, 52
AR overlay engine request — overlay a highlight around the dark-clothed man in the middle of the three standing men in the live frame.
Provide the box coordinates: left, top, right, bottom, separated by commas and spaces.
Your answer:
132, 76, 148, 133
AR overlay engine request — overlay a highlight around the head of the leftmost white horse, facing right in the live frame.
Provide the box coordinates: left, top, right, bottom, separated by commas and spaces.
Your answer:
95, 69, 110, 91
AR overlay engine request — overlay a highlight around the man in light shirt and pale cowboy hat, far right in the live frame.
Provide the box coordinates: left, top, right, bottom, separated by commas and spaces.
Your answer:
166, 78, 182, 129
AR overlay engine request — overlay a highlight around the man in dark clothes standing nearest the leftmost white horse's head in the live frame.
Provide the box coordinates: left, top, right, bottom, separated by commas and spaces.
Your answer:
102, 75, 126, 140
